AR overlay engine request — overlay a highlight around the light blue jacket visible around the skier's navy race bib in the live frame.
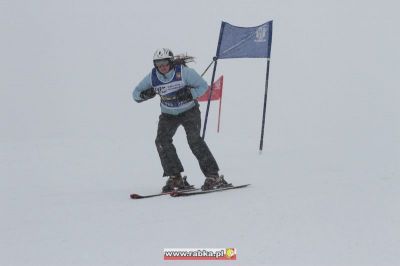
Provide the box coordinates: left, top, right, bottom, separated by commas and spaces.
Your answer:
132, 66, 208, 115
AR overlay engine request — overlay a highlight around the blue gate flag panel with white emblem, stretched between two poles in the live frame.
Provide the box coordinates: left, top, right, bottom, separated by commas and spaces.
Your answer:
216, 20, 272, 59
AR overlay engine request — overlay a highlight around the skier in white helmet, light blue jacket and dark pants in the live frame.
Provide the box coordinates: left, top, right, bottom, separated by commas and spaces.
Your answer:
133, 48, 228, 192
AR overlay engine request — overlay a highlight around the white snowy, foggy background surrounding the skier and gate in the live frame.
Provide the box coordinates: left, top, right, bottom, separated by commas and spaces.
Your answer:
0, 0, 400, 266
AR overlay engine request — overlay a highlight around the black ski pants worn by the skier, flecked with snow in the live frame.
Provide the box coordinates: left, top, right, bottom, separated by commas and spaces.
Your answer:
155, 103, 219, 176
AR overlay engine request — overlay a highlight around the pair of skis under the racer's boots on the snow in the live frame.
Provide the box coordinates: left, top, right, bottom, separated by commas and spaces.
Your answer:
130, 184, 250, 199
